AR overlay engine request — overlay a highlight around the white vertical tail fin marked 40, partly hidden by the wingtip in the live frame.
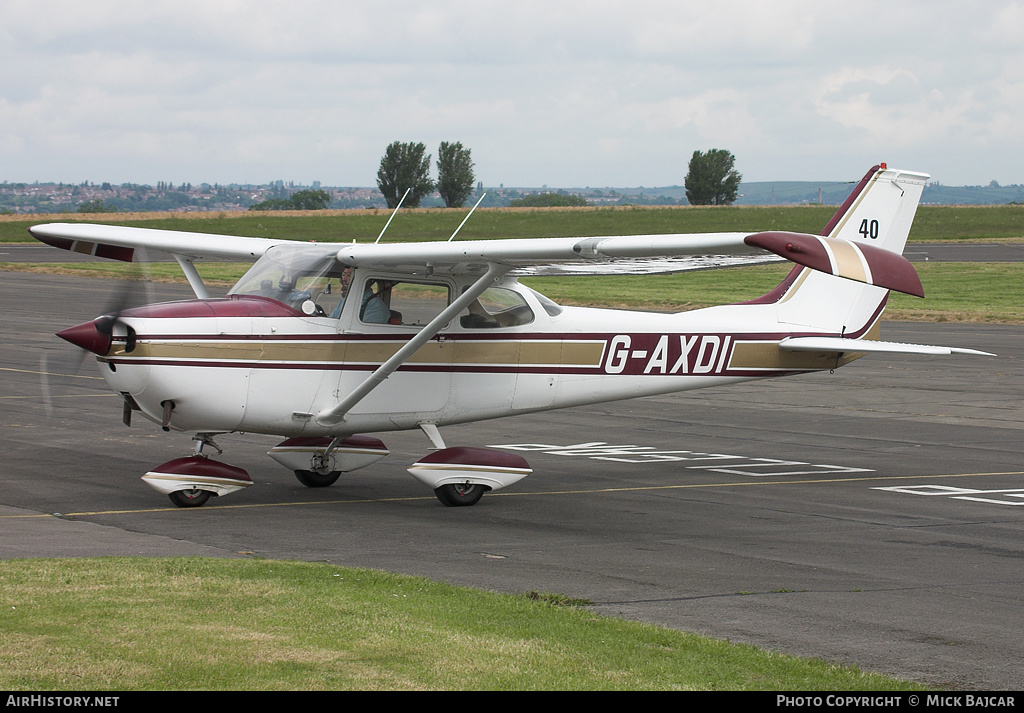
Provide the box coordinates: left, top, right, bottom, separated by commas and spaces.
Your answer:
758, 164, 928, 338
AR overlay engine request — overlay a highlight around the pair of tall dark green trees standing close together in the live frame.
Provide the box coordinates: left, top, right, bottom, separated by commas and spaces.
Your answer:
377, 141, 476, 208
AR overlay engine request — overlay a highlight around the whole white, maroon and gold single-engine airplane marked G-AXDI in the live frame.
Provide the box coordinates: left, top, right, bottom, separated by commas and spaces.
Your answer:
30, 164, 986, 507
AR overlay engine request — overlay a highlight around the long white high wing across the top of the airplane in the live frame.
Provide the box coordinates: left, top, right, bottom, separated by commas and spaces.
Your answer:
29, 223, 920, 290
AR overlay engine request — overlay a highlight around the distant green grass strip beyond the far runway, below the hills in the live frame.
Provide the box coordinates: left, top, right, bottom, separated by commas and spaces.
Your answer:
6, 205, 1024, 243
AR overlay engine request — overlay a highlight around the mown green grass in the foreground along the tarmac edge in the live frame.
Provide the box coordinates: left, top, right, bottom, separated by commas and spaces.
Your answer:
0, 558, 920, 690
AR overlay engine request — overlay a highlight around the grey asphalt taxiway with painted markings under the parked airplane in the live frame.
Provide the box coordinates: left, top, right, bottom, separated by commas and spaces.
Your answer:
0, 272, 1024, 689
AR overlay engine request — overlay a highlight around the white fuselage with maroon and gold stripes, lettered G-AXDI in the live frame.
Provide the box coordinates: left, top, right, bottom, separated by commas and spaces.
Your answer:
98, 281, 864, 436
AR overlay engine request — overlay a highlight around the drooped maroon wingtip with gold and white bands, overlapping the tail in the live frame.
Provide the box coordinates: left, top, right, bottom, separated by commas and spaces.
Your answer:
743, 232, 925, 297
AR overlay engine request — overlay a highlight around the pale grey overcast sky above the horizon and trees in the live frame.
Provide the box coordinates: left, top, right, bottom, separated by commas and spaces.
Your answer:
0, 0, 1024, 187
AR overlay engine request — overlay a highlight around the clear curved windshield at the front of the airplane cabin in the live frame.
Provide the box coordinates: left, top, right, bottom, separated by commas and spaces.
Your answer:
227, 245, 351, 317
